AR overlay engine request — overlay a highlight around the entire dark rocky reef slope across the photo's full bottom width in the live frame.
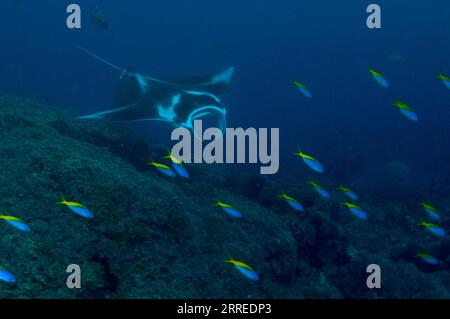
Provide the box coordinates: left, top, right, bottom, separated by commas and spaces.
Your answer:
0, 98, 450, 298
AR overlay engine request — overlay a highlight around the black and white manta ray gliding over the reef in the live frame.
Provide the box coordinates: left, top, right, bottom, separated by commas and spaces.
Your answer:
79, 47, 234, 129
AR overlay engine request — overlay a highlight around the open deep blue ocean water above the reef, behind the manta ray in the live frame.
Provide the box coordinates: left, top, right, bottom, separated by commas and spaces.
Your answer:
0, 0, 450, 300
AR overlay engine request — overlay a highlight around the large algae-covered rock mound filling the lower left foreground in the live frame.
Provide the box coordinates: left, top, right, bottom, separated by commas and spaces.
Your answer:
0, 98, 302, 298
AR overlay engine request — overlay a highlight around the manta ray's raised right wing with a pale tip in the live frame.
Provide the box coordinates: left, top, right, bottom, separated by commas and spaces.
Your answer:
170, 67, 235, 95
